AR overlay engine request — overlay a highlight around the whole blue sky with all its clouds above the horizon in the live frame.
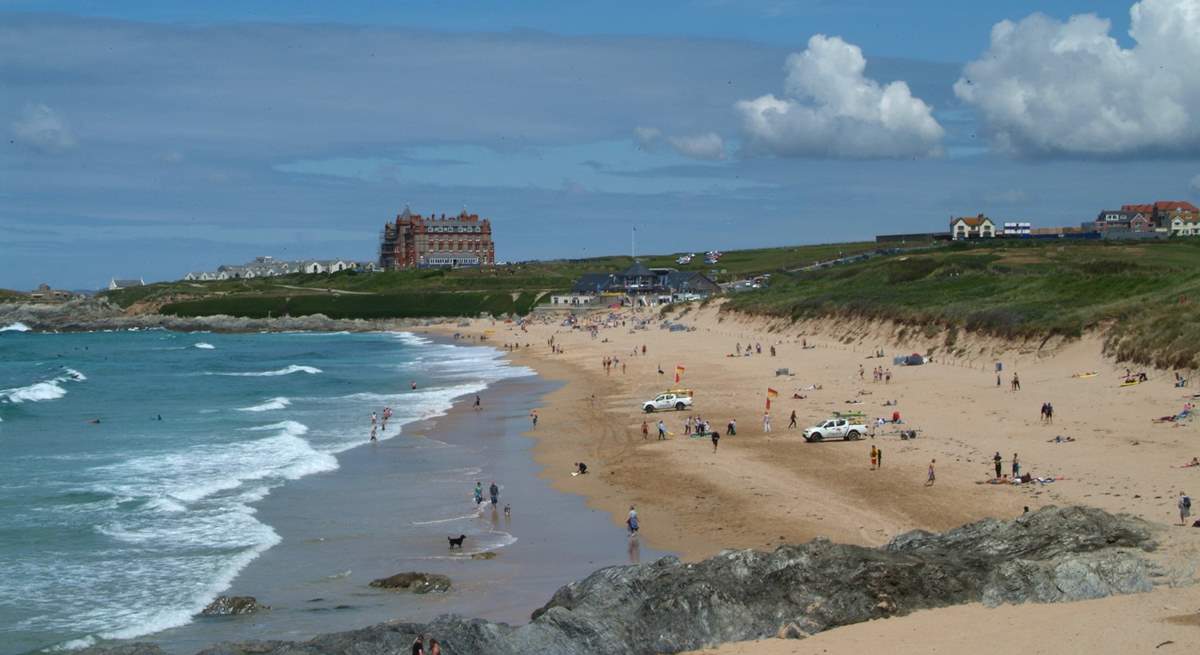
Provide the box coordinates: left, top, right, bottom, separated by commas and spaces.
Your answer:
0, 0, 1200, 289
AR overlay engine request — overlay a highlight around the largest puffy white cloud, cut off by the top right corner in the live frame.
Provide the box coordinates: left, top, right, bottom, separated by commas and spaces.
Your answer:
954, 0, 1200, 157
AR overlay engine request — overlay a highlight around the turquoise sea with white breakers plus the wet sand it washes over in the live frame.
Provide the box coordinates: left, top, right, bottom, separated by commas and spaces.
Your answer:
0, 324, 641, 655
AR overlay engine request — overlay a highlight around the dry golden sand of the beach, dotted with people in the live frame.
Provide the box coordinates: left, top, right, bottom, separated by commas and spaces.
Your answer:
420, 301, 1200, 653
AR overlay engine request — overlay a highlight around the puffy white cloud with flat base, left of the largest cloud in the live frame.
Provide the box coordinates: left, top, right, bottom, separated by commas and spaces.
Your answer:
736, 35, 944, 158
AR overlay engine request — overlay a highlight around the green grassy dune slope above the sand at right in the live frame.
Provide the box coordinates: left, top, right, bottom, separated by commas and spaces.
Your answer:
725, 240, 1200, 368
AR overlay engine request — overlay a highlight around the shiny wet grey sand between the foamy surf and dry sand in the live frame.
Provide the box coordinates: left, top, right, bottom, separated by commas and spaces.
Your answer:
124, 339, 662, 653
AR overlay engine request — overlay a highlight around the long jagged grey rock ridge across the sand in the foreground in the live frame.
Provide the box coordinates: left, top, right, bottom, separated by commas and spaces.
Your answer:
77, 507, 1156, 655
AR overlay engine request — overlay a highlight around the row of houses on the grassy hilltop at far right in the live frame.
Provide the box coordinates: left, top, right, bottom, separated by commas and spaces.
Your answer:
949, 200, 1200, 241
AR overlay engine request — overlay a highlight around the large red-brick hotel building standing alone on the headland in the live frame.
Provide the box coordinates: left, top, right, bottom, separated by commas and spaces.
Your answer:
379, 208, 496, 270
